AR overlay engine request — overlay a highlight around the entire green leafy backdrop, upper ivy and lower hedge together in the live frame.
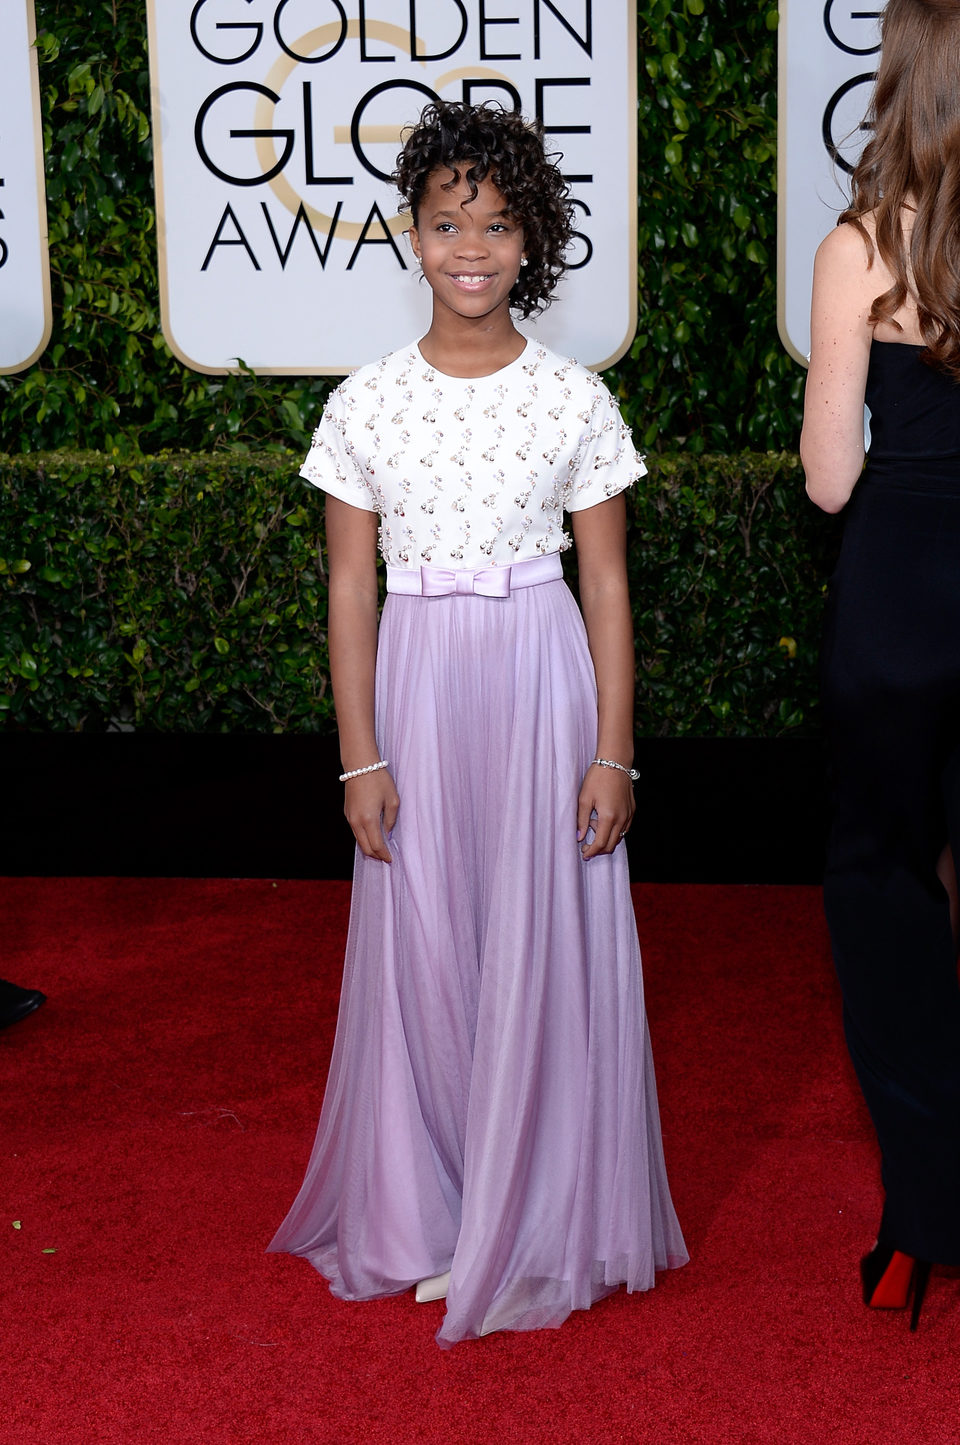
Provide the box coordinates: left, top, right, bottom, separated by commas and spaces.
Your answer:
0, 0, 836, 736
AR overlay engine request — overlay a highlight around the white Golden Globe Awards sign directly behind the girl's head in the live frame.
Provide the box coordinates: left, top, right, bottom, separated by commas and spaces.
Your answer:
149, 0, 636, 374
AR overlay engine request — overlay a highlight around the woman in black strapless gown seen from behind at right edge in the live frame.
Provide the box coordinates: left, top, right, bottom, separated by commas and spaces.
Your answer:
801, 0, 960, 1328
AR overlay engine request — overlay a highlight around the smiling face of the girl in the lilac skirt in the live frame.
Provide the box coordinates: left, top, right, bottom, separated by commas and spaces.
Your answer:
411, 162, 523, 329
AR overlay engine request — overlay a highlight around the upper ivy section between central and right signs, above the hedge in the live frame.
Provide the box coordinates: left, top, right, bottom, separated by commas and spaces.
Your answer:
614, 0, 813, 451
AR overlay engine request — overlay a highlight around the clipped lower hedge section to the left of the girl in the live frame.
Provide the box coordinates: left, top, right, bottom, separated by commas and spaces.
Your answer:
0, 454, 333, 733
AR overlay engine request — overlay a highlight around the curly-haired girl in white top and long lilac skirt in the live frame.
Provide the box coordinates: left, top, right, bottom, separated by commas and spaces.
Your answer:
270, 104, 687, 1345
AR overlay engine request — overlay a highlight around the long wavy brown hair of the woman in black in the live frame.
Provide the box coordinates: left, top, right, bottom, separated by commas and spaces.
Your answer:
840, 0, 960, 380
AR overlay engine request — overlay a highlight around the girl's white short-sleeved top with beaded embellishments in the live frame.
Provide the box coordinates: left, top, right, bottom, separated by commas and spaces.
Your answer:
301, 341, 646, 569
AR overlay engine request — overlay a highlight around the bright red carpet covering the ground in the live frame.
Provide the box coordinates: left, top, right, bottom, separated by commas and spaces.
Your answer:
0, 879, 960, 1445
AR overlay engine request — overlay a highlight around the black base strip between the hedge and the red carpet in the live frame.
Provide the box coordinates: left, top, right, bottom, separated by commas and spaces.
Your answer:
0, 733, 827, 883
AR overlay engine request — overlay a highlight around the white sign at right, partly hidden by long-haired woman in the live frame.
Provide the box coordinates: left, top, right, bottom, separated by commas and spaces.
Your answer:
778, 0, 885, 363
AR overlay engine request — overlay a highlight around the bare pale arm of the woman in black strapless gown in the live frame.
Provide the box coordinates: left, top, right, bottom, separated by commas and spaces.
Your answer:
800, 225, 885, 512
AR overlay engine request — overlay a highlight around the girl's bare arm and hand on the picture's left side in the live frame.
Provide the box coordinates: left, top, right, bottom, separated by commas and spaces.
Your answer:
327, 496, 399, 863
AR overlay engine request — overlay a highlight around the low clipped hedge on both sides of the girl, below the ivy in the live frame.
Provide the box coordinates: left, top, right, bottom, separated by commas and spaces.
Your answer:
0, 452, 834, 736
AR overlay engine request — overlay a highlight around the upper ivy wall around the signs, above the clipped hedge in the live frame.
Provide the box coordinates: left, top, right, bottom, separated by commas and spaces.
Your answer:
0, 0, 802, 452
